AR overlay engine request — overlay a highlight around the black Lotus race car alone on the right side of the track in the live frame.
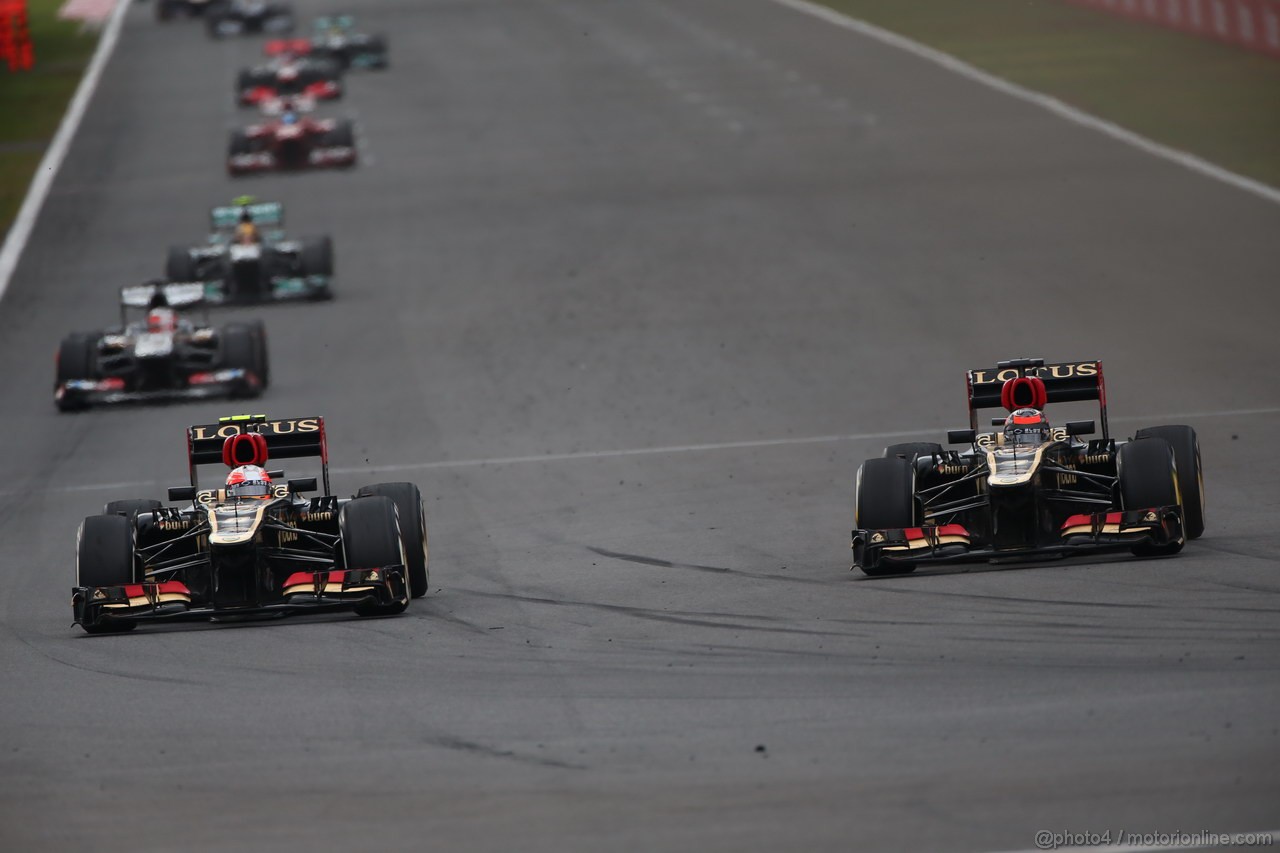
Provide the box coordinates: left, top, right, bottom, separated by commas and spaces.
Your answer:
852, 359, 1204, 575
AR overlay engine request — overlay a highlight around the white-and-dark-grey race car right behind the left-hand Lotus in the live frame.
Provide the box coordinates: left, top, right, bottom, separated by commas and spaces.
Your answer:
54, 283, 270, 411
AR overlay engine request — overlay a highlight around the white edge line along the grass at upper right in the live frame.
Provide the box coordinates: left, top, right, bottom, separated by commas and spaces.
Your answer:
769, 0, 1280, 204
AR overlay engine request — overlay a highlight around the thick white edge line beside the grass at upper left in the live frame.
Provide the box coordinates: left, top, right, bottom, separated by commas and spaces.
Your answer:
0, 0, 131, 306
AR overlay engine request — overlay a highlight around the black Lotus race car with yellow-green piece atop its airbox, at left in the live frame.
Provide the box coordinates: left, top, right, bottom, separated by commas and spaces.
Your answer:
72, 415, 429, 634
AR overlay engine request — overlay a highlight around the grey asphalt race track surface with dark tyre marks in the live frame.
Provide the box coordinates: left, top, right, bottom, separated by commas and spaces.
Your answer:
0, 0, 1280, 853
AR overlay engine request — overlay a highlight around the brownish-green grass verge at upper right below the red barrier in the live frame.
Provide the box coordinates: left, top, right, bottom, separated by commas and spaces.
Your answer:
822, 0, 1280, 186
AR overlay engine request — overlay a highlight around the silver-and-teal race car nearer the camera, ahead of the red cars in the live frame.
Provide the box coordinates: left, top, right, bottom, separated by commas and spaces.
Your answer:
165, 196, 333, 305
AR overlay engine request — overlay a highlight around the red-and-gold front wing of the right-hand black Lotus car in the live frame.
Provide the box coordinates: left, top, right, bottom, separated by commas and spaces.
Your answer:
852, 506, 1184, 571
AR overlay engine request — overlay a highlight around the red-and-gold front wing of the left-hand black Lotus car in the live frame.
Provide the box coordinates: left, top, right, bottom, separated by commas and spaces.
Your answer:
72, 565, 408, 631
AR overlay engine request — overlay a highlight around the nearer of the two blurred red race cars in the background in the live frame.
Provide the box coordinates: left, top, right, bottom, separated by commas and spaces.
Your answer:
227, 110, 356, 178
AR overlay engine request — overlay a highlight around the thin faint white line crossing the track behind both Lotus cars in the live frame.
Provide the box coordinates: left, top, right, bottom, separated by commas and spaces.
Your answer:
15, 407, 1280, 498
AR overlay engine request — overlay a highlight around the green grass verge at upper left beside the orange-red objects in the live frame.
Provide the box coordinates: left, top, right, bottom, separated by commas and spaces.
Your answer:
0, 0, 97, 234
